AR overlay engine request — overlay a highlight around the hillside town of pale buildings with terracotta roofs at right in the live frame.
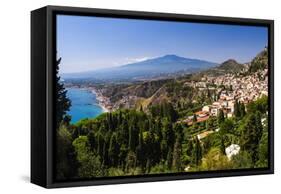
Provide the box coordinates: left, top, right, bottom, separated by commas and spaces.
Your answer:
184, 66, 268, 125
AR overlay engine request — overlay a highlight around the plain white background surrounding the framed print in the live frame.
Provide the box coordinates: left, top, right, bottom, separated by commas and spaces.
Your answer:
0, 0, 276, 194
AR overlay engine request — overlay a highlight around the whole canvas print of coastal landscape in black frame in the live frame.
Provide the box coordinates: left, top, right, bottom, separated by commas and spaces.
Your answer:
31, 6, 274, 188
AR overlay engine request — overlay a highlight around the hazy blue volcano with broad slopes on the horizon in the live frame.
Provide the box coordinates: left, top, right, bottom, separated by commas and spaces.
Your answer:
62, 55, 218, 80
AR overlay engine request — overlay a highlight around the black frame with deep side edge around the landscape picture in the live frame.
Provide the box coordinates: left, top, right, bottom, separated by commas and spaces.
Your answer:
31, 6, 274, 188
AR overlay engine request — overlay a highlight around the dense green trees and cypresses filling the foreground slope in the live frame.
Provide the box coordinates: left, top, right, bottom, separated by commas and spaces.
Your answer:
55, 94, 268, 178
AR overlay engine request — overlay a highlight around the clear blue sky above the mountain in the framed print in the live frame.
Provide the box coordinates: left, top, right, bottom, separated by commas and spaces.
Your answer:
57, 15, 268, 73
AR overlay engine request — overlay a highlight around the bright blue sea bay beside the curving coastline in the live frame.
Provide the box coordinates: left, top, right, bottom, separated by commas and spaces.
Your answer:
67, 88, 103, 123
